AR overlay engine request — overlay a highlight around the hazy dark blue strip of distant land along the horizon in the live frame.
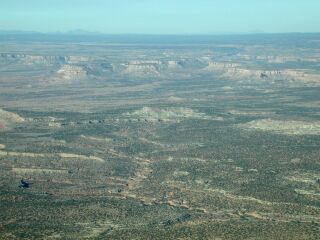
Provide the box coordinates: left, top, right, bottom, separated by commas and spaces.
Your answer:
0, 29, 320, 47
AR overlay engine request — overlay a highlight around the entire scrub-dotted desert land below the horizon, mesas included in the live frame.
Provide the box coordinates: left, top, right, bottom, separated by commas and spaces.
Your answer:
0, 34, 320, 240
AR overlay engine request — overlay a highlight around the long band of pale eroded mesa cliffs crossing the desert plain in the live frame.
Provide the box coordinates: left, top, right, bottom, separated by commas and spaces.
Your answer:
0, 53, 319, 84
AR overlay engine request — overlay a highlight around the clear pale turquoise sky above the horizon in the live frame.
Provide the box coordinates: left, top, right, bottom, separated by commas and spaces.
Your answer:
0, 0, 320, 34
